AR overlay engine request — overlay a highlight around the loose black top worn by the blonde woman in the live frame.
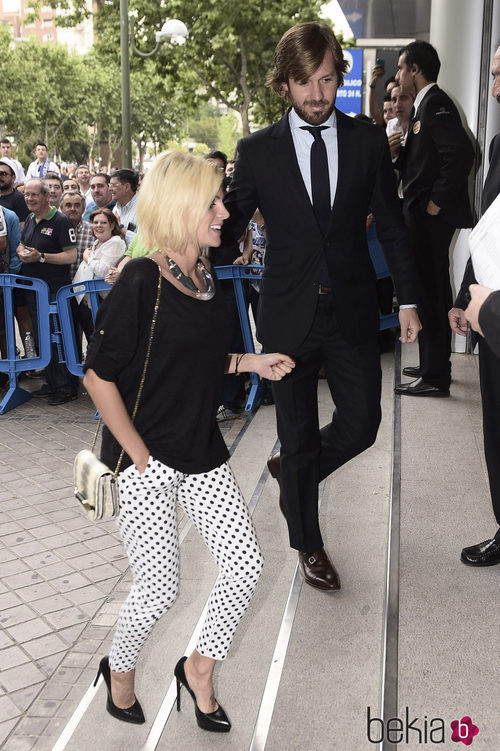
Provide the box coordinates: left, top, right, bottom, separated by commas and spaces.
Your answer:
84, 258, 231, 474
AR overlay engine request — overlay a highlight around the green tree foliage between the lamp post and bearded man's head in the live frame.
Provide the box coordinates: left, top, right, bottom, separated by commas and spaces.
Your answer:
150, 0, 323, 133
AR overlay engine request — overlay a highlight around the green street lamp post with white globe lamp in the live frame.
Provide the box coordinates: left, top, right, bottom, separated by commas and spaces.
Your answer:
120, 0, 188, 169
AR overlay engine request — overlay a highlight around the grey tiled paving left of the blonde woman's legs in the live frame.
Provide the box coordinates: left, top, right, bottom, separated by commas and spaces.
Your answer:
0, 380, 246, 751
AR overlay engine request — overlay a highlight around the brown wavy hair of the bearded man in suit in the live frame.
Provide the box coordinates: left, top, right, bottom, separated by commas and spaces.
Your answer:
266, 22, 348, 96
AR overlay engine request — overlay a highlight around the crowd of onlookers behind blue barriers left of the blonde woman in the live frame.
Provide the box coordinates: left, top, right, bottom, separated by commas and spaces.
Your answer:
0, 152, 143, 406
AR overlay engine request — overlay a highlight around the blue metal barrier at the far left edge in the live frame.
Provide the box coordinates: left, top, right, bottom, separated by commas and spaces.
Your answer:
0, 274, 51, 415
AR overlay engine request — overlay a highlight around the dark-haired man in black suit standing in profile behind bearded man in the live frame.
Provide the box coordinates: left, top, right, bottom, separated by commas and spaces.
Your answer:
396, 41, 474, 397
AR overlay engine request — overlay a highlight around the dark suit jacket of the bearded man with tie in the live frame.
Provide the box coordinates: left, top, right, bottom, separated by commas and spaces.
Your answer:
219, 110, 417, 353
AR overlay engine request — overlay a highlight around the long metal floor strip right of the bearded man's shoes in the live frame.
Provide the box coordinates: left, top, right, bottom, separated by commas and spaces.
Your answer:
380, 341, 401, 751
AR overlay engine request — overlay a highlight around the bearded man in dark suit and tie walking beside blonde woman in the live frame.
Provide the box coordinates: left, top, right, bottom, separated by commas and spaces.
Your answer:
219, 23, 420, 590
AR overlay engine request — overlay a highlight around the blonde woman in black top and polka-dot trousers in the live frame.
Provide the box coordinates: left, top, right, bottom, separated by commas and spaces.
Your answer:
84, 152, 294, 732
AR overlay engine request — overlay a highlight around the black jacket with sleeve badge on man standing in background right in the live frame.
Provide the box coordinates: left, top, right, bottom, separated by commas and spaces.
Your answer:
397, 85, 474, 227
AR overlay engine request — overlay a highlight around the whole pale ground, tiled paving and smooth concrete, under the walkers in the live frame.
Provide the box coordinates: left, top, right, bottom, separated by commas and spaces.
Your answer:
0, 347, 500, 751
